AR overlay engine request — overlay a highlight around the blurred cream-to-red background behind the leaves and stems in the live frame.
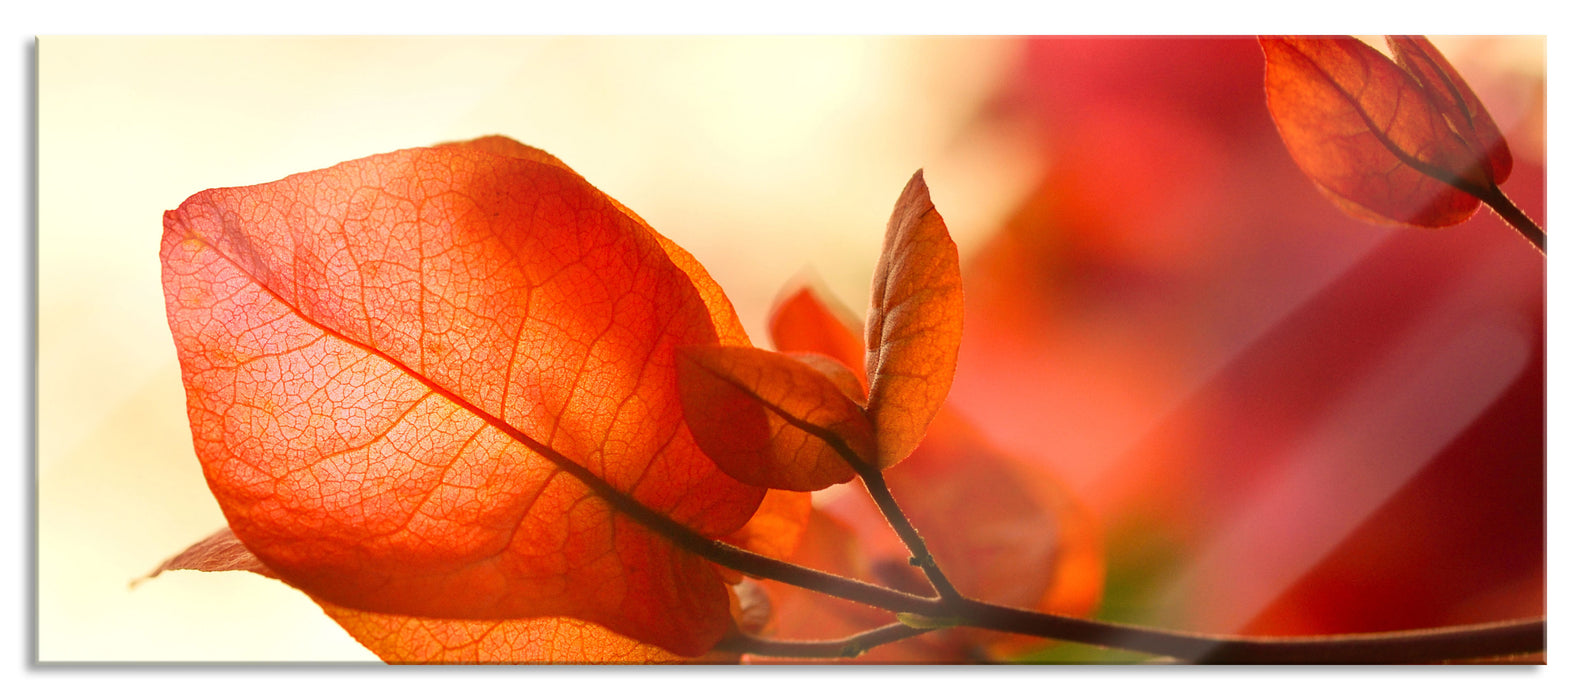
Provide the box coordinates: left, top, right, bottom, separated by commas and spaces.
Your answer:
36, 36, 1546, 660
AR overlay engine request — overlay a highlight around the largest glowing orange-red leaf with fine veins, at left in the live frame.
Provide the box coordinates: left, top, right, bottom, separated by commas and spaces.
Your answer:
161, 141, 764, 656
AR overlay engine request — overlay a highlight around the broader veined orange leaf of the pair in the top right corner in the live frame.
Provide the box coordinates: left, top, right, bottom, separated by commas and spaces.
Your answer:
1259, 36, 1509, 226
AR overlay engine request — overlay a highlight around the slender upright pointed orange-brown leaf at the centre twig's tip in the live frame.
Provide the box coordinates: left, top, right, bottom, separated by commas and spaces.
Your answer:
867, 169, 963, 467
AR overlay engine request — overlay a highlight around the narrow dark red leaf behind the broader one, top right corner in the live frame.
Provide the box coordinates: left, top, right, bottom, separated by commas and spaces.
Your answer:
1384, 36, 1511, 184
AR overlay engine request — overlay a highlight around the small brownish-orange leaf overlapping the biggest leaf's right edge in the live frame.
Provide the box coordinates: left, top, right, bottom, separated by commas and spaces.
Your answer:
677, 345, 875, 491
